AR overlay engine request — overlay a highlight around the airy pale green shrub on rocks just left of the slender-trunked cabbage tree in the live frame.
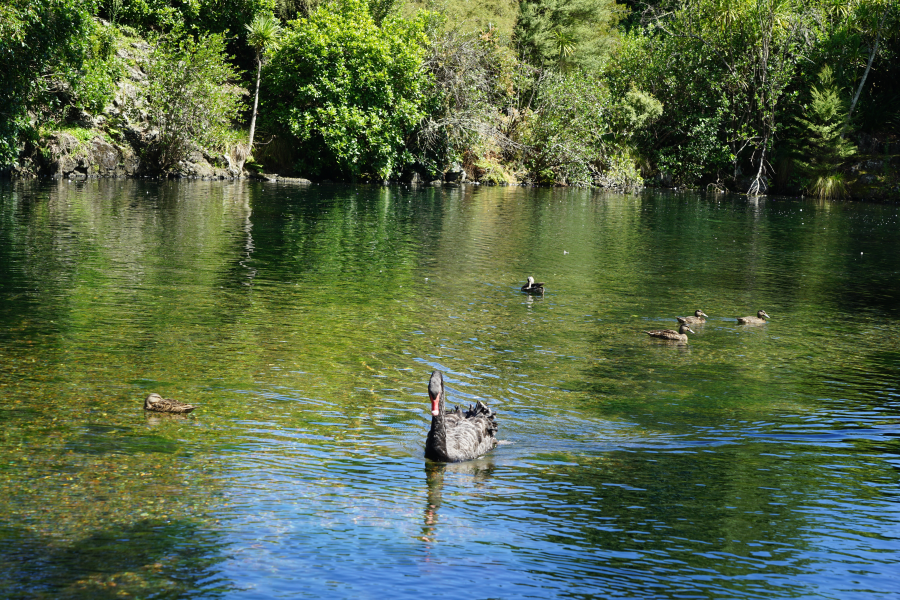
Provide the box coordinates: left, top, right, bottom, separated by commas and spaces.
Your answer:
147, 31, 240, 170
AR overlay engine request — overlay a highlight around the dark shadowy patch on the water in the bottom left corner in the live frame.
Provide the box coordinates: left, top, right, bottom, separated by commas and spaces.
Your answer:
0, 518, 231, 599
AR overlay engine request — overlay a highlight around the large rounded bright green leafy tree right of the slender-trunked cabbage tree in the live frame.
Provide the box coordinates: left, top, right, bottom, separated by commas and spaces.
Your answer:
263, 0, 426, 178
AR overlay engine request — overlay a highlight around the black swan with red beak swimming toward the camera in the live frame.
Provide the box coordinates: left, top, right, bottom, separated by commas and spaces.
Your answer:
425, 370, 497, 463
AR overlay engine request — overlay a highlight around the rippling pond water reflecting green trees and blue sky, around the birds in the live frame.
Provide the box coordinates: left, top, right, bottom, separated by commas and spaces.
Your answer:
0, 181, 900, 599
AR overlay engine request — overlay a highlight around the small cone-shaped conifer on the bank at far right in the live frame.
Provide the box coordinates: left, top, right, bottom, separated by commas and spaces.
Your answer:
792, 66, 856, 197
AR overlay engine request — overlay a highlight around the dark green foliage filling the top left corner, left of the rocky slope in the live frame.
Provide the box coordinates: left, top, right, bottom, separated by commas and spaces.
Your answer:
0, 0, 94, 167
